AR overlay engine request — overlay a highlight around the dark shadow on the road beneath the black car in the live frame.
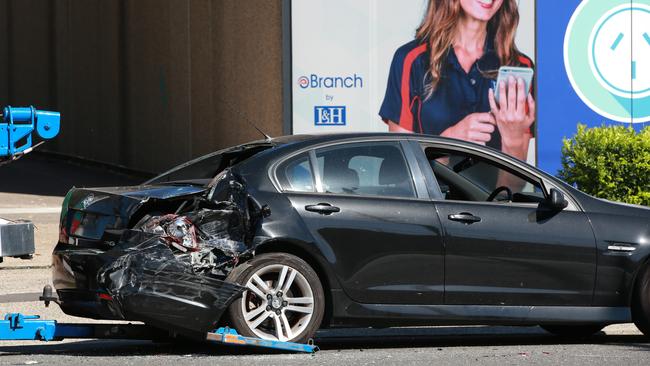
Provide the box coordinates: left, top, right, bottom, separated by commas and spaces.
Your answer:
0, 327, 650, 357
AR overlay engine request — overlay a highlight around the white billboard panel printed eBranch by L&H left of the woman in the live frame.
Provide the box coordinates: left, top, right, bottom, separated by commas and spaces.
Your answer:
291, 0, 426, 134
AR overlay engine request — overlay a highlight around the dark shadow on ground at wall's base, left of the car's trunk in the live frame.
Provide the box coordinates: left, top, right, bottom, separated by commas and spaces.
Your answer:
0, 153, 148, 196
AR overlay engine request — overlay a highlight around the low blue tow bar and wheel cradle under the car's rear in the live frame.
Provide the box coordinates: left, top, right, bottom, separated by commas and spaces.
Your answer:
0, 313, 318, 353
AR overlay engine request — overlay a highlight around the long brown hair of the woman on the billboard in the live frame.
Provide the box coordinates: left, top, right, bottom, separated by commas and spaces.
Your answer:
416, 0, 520, 98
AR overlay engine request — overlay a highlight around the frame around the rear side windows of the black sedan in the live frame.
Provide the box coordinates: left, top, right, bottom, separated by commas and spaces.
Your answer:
269, 138, 430, 200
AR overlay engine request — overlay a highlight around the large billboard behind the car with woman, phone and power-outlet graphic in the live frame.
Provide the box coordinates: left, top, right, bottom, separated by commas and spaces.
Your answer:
291, 0, 650, 174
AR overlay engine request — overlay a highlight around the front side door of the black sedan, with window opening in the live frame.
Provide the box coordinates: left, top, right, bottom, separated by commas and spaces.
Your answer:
416, 144, 596, 305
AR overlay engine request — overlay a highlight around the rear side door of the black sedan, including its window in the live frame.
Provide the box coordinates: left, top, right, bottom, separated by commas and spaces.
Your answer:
276, 141, 444, 304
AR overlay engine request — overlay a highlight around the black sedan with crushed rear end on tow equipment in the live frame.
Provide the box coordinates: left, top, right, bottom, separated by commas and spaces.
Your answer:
53, 134, 650, 342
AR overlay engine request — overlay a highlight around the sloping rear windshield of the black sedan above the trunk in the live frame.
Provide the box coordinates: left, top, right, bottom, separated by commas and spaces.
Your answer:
144, 143, 273, 185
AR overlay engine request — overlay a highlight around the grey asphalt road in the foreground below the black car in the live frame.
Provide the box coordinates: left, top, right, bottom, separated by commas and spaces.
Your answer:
0, 327, 650, 366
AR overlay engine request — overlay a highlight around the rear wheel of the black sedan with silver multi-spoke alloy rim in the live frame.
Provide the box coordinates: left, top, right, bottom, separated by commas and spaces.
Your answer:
228, 253, 325, 342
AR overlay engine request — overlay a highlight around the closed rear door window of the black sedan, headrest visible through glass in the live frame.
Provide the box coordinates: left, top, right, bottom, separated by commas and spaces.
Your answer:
316, 142, 415, 197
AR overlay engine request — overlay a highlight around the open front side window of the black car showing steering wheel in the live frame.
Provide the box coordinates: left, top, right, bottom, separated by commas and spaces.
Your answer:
425, 147, 544, 203
